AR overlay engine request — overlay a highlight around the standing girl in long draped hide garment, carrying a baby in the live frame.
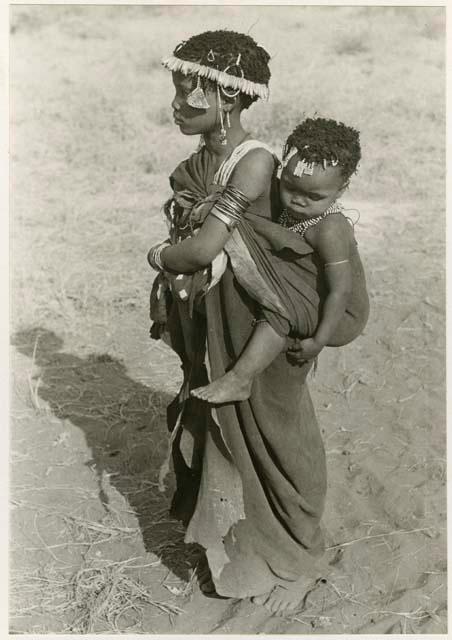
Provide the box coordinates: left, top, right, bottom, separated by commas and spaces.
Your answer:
150, 31, 336, 613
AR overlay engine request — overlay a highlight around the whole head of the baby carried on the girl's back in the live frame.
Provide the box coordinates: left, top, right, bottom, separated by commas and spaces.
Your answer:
280, 118, 361, 218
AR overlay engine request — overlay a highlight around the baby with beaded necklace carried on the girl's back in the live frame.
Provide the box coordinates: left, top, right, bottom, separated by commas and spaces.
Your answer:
192, 118, 369, 403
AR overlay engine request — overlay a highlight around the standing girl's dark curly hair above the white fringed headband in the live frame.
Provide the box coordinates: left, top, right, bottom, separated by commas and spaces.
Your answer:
173, 30, 270, 109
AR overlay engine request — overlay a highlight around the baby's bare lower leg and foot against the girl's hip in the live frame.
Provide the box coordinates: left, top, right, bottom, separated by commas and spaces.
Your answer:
192, 321, 286, 404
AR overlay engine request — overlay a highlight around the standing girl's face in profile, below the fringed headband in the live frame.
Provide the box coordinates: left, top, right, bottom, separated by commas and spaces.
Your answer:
171, 72, 219, 136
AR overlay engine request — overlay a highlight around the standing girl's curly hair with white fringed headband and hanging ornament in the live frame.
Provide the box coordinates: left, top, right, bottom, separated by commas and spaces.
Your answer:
162, 30, 270, 109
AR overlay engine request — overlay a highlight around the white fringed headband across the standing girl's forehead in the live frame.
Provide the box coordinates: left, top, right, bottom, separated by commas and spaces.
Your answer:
162, 54, 269, 100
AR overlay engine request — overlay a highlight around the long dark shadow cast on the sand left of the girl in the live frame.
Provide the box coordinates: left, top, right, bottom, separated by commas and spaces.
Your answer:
12, 327, 199, 581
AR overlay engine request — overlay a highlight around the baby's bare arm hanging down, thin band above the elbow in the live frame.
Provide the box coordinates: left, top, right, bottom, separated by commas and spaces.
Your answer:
294, 215, 352, 359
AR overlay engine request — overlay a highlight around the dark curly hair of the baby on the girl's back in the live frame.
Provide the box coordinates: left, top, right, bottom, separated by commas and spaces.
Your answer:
283, 118, 361, 180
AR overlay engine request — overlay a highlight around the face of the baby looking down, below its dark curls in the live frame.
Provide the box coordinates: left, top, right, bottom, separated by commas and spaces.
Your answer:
279, 154, 347, 219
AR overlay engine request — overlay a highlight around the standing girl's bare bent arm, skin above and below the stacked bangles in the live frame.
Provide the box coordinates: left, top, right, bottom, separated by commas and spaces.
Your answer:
160, 149, 275, 273
